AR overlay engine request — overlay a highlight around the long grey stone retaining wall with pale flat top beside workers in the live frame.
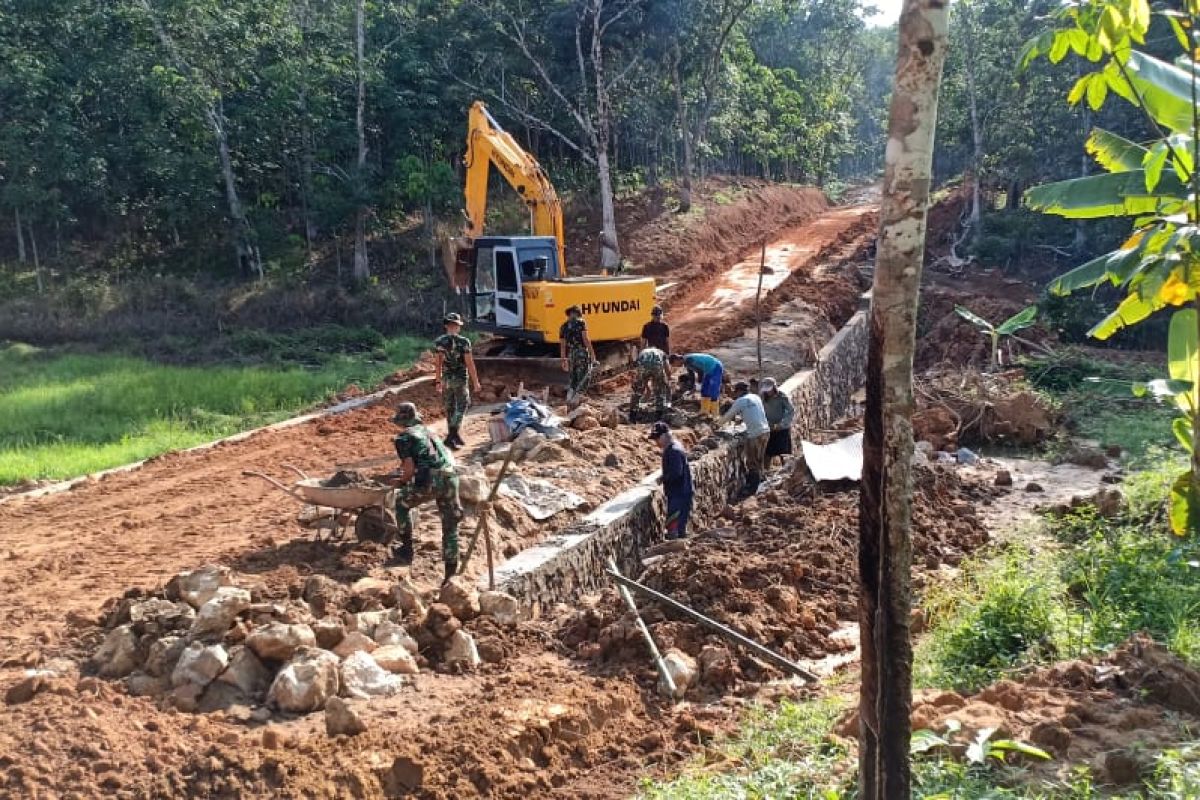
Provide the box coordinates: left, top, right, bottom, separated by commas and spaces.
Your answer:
496, 298, 868, 616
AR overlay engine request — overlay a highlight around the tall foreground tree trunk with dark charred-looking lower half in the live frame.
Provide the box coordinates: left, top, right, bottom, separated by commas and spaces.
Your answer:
858, 0, 947, 800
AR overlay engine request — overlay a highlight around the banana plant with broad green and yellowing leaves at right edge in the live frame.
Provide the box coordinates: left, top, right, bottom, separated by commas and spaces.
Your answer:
1021, 0, 1200, 534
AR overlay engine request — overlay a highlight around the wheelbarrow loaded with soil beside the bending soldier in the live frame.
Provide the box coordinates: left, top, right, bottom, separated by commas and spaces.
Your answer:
242, 464, 400, 545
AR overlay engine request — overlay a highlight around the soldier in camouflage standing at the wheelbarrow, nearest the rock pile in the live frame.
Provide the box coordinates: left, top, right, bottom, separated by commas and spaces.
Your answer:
391, 403, 462, 581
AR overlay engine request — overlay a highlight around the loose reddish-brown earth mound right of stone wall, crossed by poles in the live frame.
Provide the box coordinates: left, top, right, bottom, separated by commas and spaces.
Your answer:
559, 467, 990, 693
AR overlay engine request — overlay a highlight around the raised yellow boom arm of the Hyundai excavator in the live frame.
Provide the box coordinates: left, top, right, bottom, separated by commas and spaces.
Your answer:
463, 101, 566, 277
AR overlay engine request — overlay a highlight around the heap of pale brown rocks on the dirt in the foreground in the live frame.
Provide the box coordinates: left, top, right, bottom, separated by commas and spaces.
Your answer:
89, 565, 518, 718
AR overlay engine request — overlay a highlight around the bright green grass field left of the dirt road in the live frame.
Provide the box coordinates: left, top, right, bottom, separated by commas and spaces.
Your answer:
0, 337, 427, 485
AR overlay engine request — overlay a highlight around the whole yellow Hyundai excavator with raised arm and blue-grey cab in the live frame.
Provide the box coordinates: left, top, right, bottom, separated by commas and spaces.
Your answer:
444, 101, 655, 381
